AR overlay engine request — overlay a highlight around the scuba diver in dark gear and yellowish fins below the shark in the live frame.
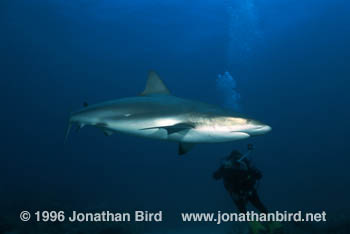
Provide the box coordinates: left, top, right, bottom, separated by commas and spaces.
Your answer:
213, 144, 281, 234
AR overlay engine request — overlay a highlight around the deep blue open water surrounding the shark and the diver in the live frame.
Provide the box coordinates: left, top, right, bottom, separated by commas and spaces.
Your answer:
0, 0, 350, 232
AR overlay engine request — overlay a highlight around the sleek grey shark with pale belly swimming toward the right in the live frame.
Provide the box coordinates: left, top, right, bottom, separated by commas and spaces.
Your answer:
65, 71, 271, 155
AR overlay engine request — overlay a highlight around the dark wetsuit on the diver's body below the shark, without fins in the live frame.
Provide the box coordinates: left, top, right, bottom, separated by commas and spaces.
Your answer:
213, 159, 267, 213
